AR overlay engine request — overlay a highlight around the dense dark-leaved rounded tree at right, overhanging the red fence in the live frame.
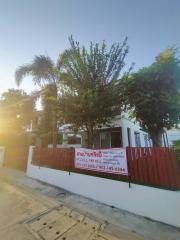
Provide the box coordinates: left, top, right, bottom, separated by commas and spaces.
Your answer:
122, 48, 180, 146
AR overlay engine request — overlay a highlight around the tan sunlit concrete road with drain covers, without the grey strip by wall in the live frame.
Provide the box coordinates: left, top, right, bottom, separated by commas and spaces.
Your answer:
0, 170, 143, 240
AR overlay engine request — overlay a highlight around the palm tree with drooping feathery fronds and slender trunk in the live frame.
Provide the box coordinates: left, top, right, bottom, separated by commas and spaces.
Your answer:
15, 55, 59, 146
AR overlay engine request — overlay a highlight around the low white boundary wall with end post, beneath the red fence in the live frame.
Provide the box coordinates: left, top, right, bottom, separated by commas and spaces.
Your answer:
27, 147, 180, 227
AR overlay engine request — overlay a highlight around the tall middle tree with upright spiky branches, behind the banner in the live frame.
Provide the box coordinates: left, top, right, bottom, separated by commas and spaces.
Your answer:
59, 37, 130, 147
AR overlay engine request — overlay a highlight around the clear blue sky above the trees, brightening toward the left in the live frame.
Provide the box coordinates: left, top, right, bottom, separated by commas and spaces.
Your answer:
0, 0, 180, 93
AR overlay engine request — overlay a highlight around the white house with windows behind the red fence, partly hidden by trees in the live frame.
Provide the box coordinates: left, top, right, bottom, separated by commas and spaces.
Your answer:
59, 114, 180, 148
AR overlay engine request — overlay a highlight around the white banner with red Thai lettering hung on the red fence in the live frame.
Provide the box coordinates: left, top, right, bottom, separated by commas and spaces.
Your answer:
75, 148, 128, 175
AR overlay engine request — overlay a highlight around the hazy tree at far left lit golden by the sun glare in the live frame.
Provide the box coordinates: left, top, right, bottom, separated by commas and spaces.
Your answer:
0, 89, 35, 146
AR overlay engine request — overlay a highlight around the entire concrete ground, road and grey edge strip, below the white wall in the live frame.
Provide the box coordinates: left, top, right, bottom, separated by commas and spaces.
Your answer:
0, 168, 180, 240
